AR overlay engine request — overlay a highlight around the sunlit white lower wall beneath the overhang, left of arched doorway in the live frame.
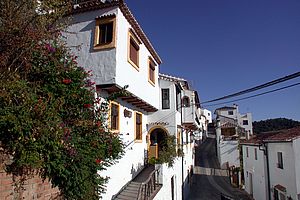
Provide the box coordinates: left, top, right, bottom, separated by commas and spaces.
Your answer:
101, 100, 147, 199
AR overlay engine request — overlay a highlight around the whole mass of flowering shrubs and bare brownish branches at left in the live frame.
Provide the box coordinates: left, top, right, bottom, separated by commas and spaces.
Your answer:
0, 0, 122, 199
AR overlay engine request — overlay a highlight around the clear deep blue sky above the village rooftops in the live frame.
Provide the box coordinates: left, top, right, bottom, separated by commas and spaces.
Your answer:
125, 0, 300, 120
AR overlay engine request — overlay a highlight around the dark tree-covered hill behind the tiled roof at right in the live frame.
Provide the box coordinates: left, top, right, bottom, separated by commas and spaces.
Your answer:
253, 118, 300, 134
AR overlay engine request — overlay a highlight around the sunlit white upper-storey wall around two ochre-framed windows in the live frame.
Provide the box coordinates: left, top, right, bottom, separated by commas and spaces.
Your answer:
116, 10, 159, 108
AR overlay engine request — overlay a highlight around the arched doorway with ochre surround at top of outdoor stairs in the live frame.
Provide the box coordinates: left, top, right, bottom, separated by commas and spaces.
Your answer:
147, 126, 168, 159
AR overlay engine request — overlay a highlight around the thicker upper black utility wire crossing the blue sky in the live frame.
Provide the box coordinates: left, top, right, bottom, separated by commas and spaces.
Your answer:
201, 72, 300, 104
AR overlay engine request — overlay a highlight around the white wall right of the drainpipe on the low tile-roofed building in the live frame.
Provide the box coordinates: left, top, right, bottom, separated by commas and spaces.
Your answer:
268, 142, 299, 199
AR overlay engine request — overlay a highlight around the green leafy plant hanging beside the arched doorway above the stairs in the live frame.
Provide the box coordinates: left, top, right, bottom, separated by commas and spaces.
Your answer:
149, 136, 183, 167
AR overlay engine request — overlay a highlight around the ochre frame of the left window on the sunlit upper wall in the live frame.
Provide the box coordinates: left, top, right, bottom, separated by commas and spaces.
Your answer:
127, 29, 141, 71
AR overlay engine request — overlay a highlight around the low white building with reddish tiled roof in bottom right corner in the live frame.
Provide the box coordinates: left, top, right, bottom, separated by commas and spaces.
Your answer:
242, 127, 300, 200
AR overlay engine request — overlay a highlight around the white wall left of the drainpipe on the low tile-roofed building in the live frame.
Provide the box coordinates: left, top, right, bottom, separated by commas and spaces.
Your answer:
242, 145, 268, 200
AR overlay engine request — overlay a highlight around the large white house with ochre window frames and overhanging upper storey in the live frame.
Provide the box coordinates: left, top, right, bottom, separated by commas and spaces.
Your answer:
64, 0, 200, 200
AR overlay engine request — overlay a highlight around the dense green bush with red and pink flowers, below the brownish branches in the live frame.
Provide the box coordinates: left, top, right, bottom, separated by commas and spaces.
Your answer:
0, 34, 122, 199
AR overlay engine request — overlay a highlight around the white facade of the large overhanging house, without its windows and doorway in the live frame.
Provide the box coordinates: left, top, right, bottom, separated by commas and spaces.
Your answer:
64, 1, 197, 200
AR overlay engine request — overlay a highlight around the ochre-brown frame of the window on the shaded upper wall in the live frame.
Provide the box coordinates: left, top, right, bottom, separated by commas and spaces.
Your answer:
94, 16, 116, 50
